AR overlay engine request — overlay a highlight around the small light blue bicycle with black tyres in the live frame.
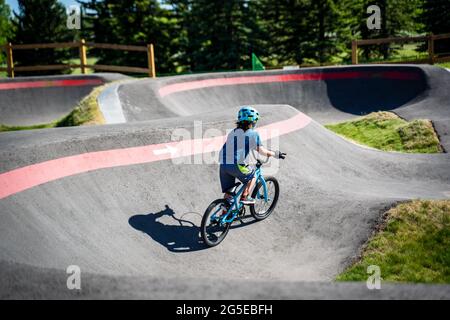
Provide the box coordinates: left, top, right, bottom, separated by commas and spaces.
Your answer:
201, 158, 280, 247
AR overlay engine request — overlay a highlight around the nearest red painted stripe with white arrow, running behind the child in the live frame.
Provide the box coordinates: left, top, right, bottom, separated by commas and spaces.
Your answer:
0, 113, 311, 199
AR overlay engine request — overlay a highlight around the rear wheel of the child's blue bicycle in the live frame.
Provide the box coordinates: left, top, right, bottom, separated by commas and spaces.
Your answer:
201, 199, 230, 247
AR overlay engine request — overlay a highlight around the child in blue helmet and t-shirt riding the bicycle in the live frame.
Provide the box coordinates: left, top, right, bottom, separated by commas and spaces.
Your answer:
219, 106, 286, 205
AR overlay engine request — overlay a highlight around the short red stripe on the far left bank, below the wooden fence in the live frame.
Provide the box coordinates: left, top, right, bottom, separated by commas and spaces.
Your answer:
0, 79, 104, 90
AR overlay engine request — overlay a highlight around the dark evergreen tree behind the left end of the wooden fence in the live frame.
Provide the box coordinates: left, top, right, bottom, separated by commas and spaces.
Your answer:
13, 0, 73, 74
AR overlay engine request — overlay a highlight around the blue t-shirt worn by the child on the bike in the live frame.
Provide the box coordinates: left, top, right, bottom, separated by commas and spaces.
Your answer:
219, 128, 262, 165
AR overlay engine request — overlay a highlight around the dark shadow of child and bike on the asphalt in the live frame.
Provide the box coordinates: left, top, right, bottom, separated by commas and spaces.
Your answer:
128, 205, 206, 252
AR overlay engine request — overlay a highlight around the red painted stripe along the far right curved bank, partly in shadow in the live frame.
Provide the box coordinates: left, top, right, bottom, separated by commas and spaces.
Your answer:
159, 71, 420, 97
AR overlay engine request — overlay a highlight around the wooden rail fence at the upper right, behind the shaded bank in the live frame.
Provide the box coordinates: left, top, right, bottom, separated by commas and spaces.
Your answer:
352, 33, 450, 64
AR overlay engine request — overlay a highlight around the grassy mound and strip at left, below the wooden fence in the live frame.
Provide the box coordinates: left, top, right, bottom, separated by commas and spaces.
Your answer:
0, 86, 105, 132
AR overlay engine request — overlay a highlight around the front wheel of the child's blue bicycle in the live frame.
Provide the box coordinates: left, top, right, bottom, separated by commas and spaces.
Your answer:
250, 176, 280, 220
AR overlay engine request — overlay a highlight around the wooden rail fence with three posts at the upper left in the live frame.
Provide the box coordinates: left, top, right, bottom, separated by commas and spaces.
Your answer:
0, 39, 156, 78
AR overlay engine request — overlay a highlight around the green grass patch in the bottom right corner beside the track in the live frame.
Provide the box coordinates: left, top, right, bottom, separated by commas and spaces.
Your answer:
336, 200, 450, 283
